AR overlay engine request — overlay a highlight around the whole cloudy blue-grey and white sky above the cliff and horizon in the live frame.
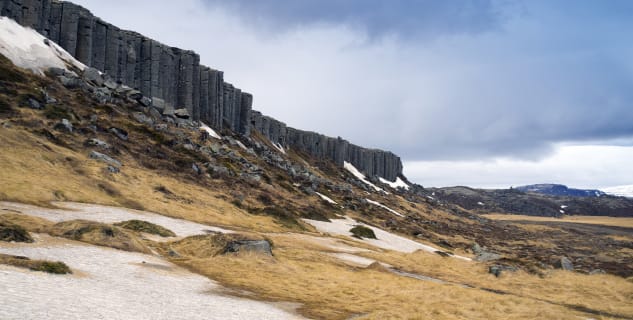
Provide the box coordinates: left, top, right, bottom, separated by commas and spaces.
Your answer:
74, 0, 633, 187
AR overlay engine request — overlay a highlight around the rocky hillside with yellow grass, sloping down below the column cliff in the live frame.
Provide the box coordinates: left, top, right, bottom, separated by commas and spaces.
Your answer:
0, 12, 633, 319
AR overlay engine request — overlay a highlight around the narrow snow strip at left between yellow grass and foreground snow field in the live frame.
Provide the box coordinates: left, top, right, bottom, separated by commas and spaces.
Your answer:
0, 202, 232, 237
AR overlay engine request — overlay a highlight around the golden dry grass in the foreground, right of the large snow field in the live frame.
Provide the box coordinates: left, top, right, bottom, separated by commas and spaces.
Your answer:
168, 235, 633, 319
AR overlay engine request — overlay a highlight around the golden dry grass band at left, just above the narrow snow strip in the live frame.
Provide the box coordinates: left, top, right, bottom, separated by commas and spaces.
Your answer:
0, 127, 284, 232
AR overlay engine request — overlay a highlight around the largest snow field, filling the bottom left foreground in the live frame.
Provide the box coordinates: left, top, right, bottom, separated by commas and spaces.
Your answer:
0, 234, 302, 320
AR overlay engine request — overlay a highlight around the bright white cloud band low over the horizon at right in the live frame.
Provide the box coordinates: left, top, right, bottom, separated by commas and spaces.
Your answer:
405, 145, 633, 188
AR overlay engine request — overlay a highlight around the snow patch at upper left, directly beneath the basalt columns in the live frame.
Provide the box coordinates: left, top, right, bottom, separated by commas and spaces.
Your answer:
0, 17, 86, 75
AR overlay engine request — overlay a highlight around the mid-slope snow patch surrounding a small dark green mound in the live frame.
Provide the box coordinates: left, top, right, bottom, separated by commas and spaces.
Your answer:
303, 217, 471, 260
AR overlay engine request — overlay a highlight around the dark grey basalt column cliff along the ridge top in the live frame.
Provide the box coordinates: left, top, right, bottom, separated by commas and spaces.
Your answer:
0, 0, 402, 181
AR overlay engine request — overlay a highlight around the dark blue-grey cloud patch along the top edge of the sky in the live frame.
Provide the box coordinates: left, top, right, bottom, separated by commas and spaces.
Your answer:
200, 0, 502, 38
